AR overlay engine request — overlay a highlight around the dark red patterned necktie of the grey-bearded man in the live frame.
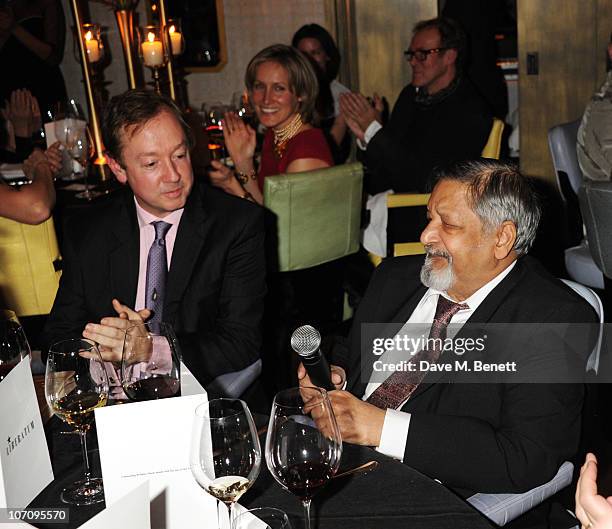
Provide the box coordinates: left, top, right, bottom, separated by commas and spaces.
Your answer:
367, 295, 469, 410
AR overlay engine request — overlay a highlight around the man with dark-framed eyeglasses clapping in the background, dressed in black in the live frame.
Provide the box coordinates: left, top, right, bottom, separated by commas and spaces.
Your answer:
341, 18, 492, 198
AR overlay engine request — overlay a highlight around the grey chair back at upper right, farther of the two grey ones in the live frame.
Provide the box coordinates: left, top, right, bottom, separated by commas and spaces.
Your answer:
548, 120, 583, 202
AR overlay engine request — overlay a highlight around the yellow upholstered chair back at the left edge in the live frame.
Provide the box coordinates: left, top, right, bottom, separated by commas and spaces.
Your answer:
0, 218, 61, 316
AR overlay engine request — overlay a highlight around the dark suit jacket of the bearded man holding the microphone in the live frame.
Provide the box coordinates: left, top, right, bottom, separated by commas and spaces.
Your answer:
332, 257, 597, 497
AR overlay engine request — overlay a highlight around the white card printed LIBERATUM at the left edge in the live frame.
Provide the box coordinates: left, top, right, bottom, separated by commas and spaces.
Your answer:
0, 357, 53, 508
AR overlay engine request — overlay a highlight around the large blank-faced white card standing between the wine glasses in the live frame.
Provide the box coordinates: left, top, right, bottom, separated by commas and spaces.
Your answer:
95, 394, 217, 529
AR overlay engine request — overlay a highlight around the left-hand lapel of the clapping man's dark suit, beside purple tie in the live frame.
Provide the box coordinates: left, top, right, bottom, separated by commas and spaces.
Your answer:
109, 192, 140, 308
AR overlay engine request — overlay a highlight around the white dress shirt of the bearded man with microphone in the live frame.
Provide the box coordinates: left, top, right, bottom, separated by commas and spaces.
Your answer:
363, 261, 516, 461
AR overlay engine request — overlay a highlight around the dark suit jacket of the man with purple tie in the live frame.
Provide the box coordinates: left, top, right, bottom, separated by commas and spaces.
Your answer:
45, 185, 266, 384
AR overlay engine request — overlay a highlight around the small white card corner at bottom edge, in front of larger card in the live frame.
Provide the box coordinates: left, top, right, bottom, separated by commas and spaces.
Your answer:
79, 481, 151, 529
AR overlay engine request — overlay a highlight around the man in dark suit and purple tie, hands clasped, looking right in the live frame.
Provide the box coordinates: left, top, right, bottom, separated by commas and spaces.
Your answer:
45, 90, 265, 394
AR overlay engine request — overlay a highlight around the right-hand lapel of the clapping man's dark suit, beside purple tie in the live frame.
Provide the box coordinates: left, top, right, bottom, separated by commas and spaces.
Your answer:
164, 187, 210, 321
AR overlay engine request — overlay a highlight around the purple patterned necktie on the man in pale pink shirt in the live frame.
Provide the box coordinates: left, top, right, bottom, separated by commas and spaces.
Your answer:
145, 220, 172, 326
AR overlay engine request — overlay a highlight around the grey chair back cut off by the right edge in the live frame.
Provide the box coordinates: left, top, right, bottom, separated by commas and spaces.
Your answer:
578, 180, 612, 278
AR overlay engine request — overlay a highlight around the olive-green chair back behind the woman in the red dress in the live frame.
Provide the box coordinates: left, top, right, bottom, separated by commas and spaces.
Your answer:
264, 163, 363, 272
